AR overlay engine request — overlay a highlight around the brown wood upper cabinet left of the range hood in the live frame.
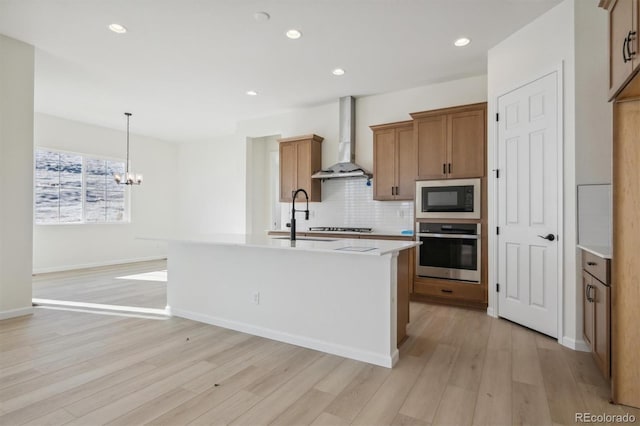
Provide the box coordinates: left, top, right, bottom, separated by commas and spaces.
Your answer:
278, 135, 324, 202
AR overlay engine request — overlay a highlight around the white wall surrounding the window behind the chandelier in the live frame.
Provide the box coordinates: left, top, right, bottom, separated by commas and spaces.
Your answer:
30, 112, 179, 272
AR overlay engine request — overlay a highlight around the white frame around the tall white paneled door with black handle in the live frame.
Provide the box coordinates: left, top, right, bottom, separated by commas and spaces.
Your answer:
487, 63, 565, 344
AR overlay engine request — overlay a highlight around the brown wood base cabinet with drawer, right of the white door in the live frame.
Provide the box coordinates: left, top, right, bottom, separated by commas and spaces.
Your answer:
582, 251, 611, 378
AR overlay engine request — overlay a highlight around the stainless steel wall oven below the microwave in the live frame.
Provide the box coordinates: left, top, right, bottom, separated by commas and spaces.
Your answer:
416, 222, 482, 283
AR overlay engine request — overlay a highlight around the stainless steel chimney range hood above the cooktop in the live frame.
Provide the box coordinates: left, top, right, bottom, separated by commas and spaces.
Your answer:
311, 96, 373, 179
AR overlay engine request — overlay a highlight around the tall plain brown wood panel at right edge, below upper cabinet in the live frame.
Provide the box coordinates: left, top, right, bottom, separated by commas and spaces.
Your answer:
611, 78, 640, 408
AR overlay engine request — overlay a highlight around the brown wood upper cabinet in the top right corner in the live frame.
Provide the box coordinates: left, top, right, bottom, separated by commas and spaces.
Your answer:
600, 0, 640, 99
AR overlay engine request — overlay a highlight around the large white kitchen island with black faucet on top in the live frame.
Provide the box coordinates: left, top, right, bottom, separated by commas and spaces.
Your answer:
163, 235, 418, 367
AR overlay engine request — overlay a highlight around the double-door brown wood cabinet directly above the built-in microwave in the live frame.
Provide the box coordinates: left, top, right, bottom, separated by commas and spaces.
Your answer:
411, 103, 487, 179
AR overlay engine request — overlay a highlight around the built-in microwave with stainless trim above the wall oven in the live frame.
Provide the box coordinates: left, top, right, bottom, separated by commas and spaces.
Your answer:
416, 178, 480, 219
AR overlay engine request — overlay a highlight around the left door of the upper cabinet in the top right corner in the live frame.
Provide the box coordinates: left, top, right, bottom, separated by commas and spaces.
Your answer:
609, 0, 638, 96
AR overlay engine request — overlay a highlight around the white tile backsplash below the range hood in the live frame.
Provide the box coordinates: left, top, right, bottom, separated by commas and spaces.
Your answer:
281, 179, 413, 233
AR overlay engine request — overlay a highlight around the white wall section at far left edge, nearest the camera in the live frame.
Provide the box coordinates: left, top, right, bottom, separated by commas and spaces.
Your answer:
0, 35, 34, 319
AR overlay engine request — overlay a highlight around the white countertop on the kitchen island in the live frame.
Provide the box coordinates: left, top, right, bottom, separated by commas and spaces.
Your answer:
148, 231, 421, 256
